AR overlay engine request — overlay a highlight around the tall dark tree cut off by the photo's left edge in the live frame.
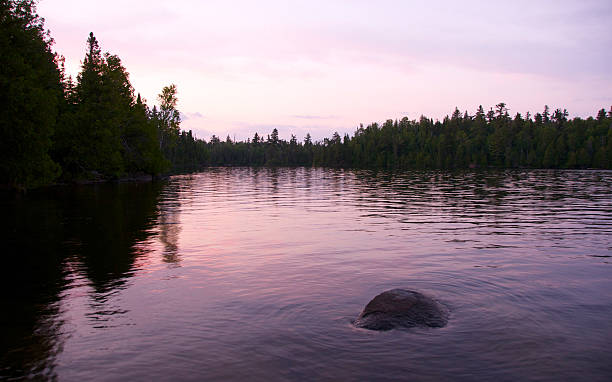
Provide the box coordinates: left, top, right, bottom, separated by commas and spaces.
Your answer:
0, 0, 61, 188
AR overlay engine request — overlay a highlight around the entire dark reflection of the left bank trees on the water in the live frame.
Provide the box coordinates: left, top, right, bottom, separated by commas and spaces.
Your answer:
0, 183, 162, 380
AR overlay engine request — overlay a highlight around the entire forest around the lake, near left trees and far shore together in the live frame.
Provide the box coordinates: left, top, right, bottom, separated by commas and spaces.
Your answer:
0, 0, 612, 190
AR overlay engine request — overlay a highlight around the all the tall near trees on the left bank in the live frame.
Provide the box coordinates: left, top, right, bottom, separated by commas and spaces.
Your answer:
0, 0, 207, 189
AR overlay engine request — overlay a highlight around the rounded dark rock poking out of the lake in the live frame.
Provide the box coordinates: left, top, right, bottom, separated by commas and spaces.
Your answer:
353, 289, 448, 330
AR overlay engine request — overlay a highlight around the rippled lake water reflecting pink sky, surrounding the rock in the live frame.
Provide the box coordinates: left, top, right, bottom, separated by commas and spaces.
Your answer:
0, 168, 612, 381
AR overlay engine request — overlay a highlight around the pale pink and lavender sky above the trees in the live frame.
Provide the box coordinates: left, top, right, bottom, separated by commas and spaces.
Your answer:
38, 0, 612, 140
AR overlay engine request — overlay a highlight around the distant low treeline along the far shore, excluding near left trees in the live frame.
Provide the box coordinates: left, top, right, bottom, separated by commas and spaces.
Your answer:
207, 103, 612, 169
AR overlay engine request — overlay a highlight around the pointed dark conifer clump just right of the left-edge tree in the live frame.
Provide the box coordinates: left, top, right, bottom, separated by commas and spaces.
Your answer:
54, 33, 165, 179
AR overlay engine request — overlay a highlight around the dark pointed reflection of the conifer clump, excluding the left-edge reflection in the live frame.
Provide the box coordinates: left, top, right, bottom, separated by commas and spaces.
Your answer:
65, 183, 161, 294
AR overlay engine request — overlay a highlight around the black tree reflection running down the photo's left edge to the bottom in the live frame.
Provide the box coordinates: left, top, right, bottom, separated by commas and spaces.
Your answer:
0, 195, 66, 380
